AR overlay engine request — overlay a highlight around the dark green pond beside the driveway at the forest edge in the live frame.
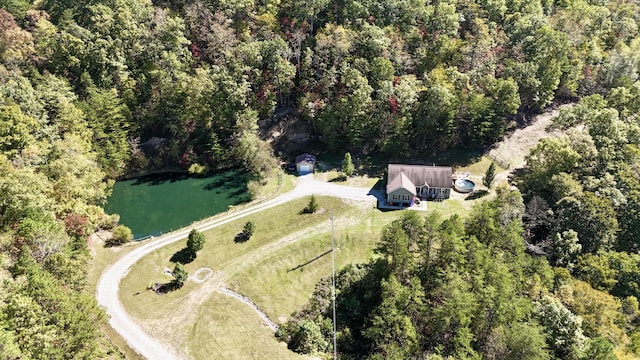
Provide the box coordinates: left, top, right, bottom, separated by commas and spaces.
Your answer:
105, 171, 249, 239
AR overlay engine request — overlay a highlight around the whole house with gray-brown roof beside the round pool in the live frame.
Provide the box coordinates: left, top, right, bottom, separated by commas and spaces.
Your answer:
387, 164, 453, 206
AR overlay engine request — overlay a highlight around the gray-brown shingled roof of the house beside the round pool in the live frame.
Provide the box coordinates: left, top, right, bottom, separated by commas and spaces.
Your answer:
387, 164, 453, 189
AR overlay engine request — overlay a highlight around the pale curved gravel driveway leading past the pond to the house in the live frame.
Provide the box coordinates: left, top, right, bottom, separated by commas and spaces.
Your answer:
96, 175, 376, 360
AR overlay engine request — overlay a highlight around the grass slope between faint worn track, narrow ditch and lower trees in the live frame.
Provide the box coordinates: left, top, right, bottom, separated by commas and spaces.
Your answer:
225, 201, 399, 322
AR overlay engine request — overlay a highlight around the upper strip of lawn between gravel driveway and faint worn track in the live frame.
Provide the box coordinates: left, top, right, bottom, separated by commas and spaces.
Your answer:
120, 198, 350, 319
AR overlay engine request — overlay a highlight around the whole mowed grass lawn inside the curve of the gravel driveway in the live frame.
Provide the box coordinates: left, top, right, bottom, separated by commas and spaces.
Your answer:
120, 197, 468, 359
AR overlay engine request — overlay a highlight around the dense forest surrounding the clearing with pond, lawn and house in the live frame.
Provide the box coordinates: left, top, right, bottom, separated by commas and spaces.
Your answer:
0, 0, 640, 359
